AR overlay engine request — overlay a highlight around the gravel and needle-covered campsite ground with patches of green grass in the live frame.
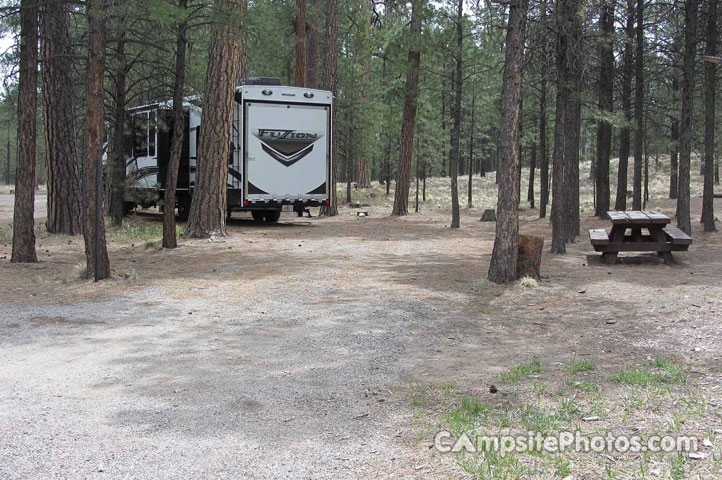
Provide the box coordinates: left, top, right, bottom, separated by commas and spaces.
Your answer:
0, 162, 722, 479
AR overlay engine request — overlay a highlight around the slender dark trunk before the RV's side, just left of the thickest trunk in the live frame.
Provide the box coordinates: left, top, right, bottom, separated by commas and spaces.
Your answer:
163, 0, 187, 248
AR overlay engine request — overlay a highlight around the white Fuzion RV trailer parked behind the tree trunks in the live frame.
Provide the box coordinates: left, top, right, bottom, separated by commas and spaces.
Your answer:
126, 78, 335, 222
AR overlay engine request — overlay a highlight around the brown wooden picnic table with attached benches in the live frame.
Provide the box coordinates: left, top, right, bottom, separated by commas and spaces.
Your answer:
589, 210, 692, 265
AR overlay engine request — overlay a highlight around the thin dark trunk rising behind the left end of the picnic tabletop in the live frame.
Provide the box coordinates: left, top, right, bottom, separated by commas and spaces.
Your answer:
614, 0, 634, 210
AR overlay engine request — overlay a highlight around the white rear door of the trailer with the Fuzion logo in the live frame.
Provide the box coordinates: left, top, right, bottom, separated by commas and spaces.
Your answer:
243, 101, 331, 202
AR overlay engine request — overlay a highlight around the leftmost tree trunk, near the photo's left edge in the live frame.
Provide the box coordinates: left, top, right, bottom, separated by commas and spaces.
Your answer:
10, 0, 38, 263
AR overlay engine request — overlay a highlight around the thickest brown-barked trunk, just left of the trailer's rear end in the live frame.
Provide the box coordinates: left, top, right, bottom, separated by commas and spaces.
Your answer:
186, 0, 241, 238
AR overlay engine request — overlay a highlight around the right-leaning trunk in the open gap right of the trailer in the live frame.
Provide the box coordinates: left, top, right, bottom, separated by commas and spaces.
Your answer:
391, 0, 423, 215
